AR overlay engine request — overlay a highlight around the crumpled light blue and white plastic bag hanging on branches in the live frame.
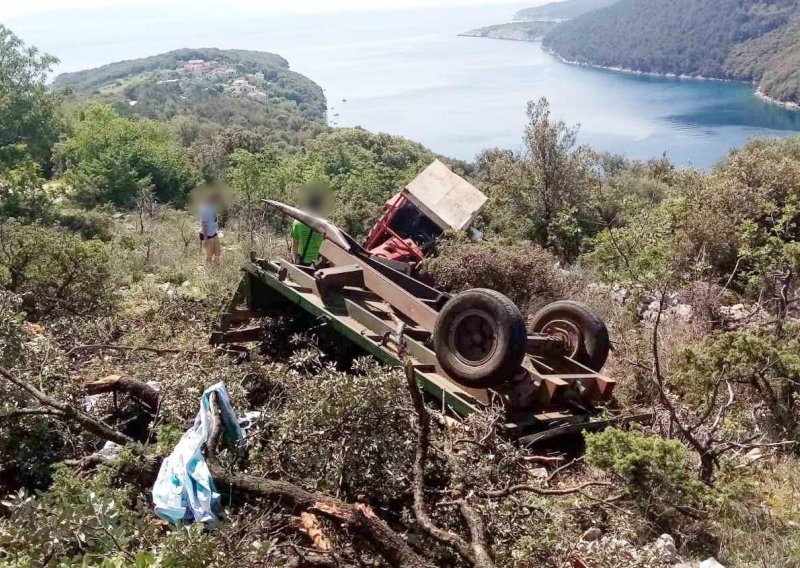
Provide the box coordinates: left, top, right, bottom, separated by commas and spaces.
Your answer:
153, 382, 244, 523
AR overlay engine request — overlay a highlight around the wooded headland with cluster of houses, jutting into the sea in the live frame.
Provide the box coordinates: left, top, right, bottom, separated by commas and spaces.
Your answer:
53, 48, 326, 149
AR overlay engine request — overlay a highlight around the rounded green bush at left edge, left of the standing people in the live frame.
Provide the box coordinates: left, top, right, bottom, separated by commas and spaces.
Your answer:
0, 222, 113, 318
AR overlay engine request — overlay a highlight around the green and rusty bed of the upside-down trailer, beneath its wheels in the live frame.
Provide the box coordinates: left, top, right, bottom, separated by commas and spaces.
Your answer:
211, 259, 649, 443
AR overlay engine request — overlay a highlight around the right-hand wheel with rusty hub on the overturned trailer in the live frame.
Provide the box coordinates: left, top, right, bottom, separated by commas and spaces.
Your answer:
529, 301, 611, 373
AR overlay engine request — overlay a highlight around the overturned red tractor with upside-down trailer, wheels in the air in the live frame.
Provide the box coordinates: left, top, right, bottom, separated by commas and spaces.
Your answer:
216, 162, 636, 443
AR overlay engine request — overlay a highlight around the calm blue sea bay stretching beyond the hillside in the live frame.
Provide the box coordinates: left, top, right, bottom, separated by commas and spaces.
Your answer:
10, 0, 800, 168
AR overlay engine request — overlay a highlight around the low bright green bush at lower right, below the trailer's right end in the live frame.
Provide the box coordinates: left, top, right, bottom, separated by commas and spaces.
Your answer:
585, 428, 710, 525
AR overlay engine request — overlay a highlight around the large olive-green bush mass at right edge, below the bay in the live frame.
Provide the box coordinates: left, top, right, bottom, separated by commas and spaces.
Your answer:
582, 138, 800, 306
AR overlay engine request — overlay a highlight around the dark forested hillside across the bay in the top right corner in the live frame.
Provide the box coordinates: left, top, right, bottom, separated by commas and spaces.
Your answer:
545, 0, 800, 102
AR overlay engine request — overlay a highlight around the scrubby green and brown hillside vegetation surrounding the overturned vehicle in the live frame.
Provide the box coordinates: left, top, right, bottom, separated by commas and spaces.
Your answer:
0, 22, 800, 568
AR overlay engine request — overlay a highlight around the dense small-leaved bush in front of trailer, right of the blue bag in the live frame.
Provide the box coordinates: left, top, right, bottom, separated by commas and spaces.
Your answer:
255, 360, 413, 504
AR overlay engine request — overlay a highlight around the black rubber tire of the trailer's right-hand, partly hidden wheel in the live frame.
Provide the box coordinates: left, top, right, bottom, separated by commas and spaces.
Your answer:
528, 300, 611, 373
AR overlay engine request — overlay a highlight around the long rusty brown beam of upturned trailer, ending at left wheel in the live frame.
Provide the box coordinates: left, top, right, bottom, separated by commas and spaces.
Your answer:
320, 240, 439, 333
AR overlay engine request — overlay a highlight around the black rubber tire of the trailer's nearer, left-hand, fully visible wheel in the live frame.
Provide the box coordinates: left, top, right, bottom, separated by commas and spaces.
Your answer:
433, 288, 528, 388
